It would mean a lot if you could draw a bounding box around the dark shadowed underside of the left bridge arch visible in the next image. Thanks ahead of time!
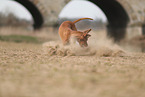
[14,0,44,29]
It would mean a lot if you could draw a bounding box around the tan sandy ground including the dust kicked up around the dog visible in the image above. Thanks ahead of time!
[0,27,145,97]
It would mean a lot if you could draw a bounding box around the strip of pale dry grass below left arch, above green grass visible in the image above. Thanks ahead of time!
[0,27,59,42]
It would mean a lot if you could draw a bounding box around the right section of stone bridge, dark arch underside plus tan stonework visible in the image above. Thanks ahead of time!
[58,0,145,41]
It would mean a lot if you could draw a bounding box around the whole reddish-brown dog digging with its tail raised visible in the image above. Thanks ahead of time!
[59,18,93,47]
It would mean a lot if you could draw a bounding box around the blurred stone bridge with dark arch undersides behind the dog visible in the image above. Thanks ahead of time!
[10,0,145,41]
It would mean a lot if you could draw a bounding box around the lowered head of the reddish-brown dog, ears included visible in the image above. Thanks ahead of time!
[72,29,91,47]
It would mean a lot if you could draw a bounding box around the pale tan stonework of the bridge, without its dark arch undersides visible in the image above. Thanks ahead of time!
[16,0,145,39]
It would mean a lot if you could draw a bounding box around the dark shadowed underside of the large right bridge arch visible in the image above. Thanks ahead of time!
[89,0,130,41]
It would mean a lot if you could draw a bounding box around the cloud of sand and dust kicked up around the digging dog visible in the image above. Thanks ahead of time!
[43,31,127,57]
